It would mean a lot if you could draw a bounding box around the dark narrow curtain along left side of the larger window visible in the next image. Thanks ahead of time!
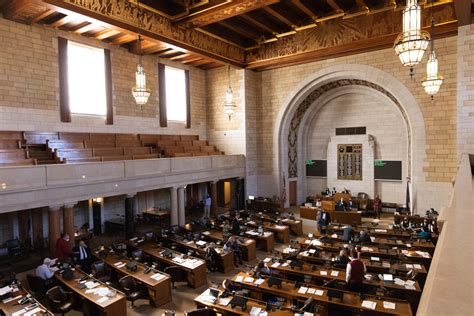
[58,37,71,123]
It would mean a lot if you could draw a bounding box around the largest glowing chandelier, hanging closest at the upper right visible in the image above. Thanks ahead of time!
[393,0,430,76]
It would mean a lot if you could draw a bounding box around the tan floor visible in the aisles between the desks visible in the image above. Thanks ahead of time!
[13,208,393,316]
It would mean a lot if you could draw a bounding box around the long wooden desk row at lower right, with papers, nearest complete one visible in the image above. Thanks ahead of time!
[232,272,412,315]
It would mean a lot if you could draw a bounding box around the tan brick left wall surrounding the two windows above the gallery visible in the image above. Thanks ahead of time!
[0,17,207,139]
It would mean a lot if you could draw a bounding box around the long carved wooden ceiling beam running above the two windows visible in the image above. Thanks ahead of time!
[39,0,246,67]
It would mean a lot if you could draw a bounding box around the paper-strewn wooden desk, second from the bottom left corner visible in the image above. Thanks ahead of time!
[54,269,127,316]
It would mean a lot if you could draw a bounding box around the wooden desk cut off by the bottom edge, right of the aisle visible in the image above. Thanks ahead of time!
[194,290,294,316]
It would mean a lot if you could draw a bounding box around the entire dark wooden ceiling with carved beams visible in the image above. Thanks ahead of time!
[0,0,472,69]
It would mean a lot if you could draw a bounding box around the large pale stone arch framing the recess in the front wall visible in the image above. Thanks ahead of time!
[274,64,426,207]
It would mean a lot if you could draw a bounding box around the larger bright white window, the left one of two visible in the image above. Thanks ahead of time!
[67,41,107,116]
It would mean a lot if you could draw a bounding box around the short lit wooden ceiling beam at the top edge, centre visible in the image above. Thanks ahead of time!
[173,0,280,28]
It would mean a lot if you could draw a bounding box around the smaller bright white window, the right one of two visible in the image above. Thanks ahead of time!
[165,66,187,123]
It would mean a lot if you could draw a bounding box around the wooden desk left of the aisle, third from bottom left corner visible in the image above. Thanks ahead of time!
[92,252,171,307]
